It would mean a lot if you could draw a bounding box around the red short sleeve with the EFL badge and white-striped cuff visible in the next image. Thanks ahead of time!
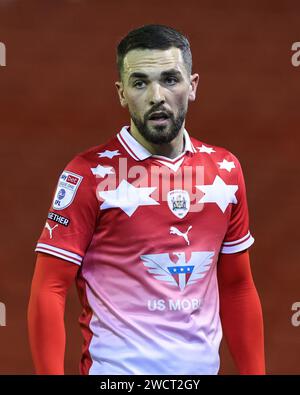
[35,156,98,265]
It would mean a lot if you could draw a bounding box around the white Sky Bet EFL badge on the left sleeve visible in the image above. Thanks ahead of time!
[52,171,82,210]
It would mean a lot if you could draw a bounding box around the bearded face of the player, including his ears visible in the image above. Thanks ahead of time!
[116,47,199,144]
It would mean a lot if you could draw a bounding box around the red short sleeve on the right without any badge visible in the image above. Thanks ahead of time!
[220,154,254,254]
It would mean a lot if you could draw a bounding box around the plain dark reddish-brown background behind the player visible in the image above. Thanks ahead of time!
[0,0,300,374]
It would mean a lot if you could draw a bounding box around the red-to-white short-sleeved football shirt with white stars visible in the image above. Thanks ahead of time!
[36,126,254,374]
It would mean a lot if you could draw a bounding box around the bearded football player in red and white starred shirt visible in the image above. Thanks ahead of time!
[28,25,265,375]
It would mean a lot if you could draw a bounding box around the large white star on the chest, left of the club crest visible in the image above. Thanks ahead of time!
[99,180,159,217]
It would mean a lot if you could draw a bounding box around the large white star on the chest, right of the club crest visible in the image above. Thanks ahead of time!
[196,176,238,213]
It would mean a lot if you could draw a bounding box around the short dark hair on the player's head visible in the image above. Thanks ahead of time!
[117,24,192,80]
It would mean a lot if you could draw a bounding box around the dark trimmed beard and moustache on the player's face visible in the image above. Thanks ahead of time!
[130,108,187,144]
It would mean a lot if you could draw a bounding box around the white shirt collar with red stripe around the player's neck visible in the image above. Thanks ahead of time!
[117,125,196,160]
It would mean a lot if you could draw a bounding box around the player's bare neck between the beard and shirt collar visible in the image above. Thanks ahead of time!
[130,120,184,159]
